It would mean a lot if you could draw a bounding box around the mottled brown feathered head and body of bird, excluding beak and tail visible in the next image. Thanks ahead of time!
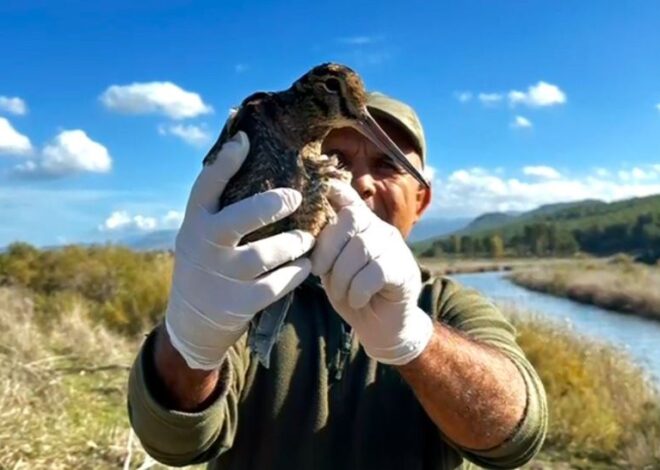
[204,64,366,243]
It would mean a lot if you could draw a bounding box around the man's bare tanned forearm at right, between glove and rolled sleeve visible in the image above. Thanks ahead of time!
[398,323,527,450]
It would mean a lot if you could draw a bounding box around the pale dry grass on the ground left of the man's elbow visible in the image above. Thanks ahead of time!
[0,288,159,469]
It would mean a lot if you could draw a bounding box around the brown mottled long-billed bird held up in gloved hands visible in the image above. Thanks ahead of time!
[203,63,429,368]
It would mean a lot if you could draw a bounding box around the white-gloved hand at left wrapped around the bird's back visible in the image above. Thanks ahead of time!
[165,132,314,370]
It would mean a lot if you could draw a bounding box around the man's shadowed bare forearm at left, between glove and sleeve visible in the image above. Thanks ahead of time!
[154,326,226,412]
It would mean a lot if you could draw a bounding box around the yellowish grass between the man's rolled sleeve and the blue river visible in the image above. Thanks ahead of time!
[507,310,660,469]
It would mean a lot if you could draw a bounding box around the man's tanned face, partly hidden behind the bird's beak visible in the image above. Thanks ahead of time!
[322,120,431,237]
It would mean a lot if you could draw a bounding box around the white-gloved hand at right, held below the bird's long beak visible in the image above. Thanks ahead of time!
[311,181,433,365]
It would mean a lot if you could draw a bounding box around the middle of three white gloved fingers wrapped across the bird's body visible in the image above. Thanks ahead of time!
[229,230,316,281]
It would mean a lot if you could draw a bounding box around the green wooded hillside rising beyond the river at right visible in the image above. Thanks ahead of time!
[414,195,660,261]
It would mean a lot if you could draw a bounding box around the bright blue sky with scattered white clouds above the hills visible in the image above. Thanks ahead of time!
[0,0,660,246]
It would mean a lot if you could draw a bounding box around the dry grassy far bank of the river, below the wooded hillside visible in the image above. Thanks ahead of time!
[509,255,660,320]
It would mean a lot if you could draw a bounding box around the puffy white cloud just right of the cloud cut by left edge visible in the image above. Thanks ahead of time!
[14,129,112,178]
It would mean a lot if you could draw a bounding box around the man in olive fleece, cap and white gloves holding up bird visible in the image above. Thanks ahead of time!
[128,94,547,469]
